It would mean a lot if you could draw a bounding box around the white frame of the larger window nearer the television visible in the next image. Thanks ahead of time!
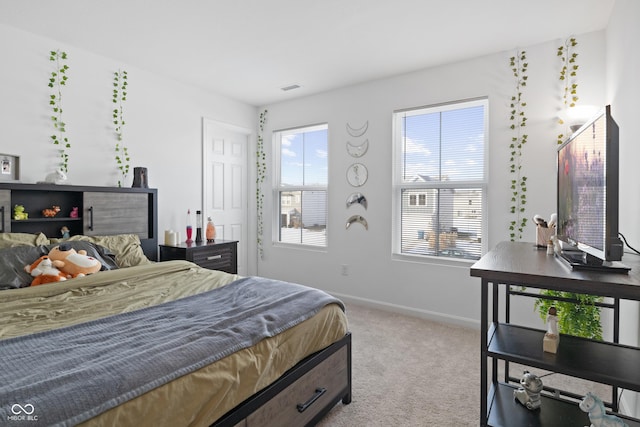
[391,97,490,264]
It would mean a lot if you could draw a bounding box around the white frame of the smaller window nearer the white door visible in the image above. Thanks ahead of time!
[271,122,331,252]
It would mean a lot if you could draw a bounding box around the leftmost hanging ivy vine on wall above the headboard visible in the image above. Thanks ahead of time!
[48,50,71,173]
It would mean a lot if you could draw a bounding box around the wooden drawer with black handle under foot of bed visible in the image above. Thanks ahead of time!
[246,346,349,427]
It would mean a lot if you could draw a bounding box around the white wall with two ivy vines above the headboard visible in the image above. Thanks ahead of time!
[0,25,257,249]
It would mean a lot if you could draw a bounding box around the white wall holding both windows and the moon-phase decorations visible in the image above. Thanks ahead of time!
[258,32,605,324]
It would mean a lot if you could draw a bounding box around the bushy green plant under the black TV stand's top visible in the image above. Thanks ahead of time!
[535,290,602,341]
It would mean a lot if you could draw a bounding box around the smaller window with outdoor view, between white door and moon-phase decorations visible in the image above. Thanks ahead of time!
[274,124,328,247]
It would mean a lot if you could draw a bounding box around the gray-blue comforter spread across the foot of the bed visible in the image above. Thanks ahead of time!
[0,277,344,426]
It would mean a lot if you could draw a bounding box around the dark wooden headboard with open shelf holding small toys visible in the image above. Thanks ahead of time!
[0,183,158,261]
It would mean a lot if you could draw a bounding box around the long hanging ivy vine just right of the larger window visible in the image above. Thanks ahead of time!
[509,51,529,241]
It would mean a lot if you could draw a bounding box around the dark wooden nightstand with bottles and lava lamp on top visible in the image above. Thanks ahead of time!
[160,240,238,274]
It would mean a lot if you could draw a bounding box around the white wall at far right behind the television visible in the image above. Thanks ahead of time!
[606,0,640,416]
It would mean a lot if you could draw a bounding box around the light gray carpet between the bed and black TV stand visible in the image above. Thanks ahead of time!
[319,305,480,427]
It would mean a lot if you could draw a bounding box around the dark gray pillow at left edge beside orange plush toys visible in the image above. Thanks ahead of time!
[0,245,47,289]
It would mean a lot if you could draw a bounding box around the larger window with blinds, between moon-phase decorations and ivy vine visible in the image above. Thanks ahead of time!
[393,99,488,259]
